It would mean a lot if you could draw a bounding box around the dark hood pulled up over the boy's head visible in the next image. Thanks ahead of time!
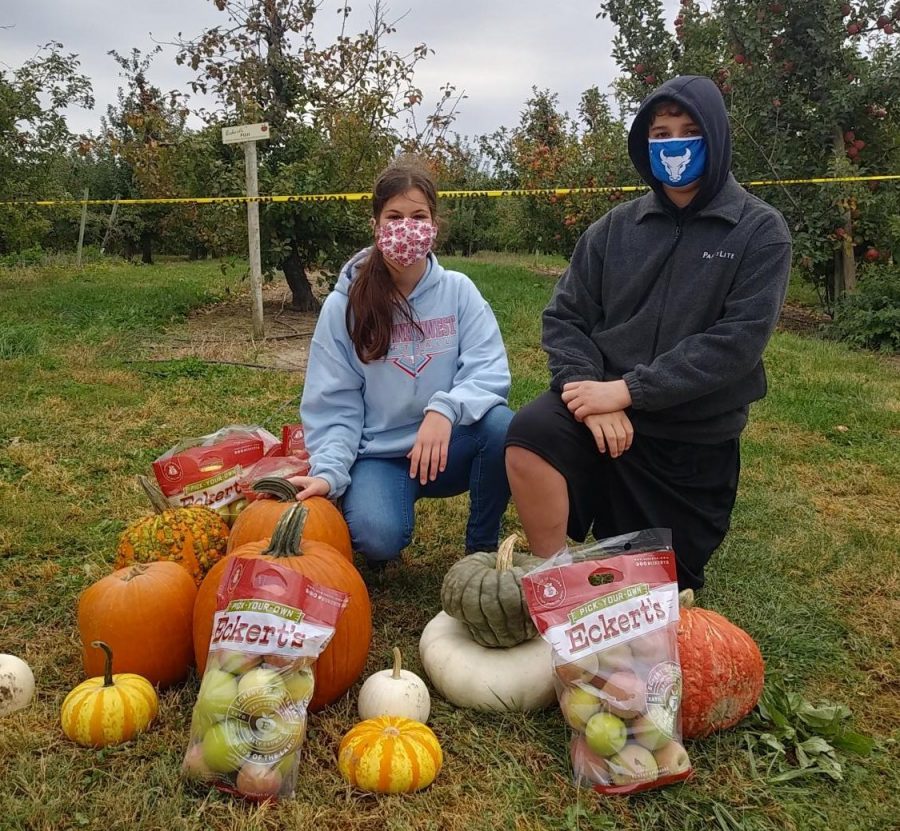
[628,75,731,212]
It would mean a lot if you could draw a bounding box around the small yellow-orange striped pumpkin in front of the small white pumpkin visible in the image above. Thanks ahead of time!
[338,716,444,793]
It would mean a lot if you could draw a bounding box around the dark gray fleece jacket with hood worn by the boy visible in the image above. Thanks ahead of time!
[542,76,791,444]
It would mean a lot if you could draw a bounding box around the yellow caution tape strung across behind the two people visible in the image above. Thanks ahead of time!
[0,174,900,208]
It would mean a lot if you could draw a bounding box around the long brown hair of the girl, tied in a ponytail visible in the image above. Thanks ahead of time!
[347,159,437,363]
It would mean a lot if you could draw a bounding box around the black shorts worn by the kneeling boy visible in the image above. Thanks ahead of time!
[506,391,741,588]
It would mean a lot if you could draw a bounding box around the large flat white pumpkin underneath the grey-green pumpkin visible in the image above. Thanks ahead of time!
[419,612,556,712]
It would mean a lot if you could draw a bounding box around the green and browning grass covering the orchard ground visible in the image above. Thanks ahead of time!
[0,255,900,831]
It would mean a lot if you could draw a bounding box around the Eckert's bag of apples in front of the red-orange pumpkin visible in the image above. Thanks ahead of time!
[522,529,691,794]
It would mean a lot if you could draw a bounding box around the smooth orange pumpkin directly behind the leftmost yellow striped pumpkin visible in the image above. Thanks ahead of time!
[78,561,197,687]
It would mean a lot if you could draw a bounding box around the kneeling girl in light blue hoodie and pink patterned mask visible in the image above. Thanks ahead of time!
[293,162,512,566]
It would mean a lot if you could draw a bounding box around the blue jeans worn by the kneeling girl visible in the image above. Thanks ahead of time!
[342,404,513,562]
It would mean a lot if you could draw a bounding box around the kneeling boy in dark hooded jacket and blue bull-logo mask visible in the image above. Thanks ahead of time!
[506,75,791,588]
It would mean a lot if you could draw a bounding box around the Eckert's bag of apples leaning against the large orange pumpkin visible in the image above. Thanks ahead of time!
[182,558,348,801]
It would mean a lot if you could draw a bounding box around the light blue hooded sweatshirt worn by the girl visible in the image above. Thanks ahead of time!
[300,249,510,498]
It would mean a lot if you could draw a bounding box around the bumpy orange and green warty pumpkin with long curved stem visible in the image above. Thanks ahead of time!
[116,476,228,585]
